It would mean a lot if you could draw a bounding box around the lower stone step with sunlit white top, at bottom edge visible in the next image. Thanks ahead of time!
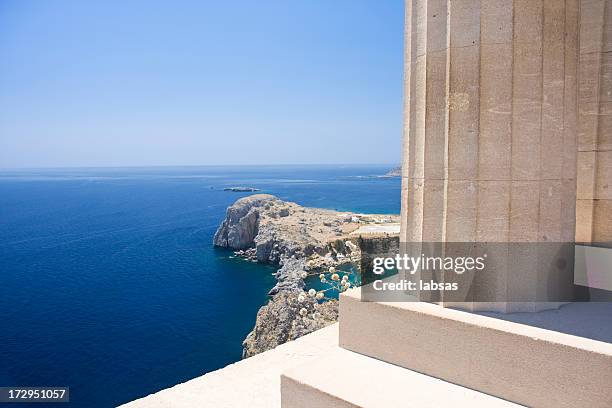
[281,347,519,408]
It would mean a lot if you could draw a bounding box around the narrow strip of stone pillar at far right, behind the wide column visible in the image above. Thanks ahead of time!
[576,0,612,247]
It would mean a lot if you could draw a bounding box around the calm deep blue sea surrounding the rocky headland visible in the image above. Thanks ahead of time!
[0,166,400,408]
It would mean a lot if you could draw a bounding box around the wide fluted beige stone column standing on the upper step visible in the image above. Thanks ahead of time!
[401,0,579,311]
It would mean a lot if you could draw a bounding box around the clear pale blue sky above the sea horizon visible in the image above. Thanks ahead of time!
[0,0,403,168]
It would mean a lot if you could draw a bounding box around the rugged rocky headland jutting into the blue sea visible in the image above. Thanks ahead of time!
[214,194,399,357]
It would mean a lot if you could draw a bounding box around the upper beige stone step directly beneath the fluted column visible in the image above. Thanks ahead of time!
[339,288,612,408]
